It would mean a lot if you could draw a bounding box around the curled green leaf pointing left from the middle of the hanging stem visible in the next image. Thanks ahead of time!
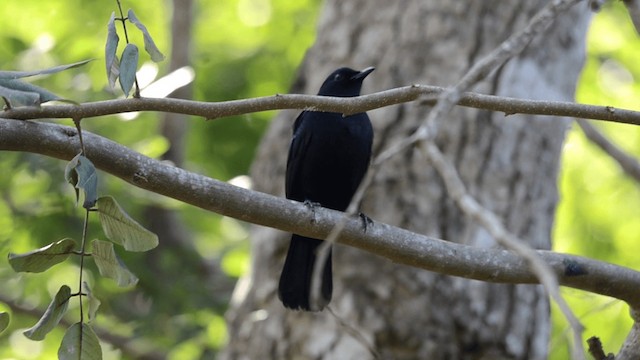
[9,238,76,273]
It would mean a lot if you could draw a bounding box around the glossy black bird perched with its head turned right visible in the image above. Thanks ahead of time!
[278,67,374,311]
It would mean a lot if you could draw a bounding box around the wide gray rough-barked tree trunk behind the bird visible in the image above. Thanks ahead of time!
[223,0,589,359]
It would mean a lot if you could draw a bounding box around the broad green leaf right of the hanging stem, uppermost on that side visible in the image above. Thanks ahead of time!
[97,196,158,251]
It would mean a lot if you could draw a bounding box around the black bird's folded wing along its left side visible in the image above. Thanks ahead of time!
[285,111,312,201]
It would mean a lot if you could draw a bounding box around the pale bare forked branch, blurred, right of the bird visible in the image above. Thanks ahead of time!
[382,0,585,359]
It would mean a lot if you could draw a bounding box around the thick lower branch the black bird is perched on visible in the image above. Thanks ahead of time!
[0,119,640,308]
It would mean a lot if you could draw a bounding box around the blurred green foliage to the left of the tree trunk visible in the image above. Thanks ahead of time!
[0,0,320,359]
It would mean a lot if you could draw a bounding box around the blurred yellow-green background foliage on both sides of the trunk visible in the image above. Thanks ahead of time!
[0,0,640,359]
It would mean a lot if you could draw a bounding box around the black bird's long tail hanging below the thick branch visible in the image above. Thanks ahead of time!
[278,234,333,311]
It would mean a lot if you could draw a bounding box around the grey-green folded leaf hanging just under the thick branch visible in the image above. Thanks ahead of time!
[64,154,98,209]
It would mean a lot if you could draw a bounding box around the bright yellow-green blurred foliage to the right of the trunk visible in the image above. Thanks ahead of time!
[551,1,640,359]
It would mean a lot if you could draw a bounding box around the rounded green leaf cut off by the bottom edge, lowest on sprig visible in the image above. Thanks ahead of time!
[58,322,102,360]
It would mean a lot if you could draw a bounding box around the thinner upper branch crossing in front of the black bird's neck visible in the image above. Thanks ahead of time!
[0,85,640,125]
